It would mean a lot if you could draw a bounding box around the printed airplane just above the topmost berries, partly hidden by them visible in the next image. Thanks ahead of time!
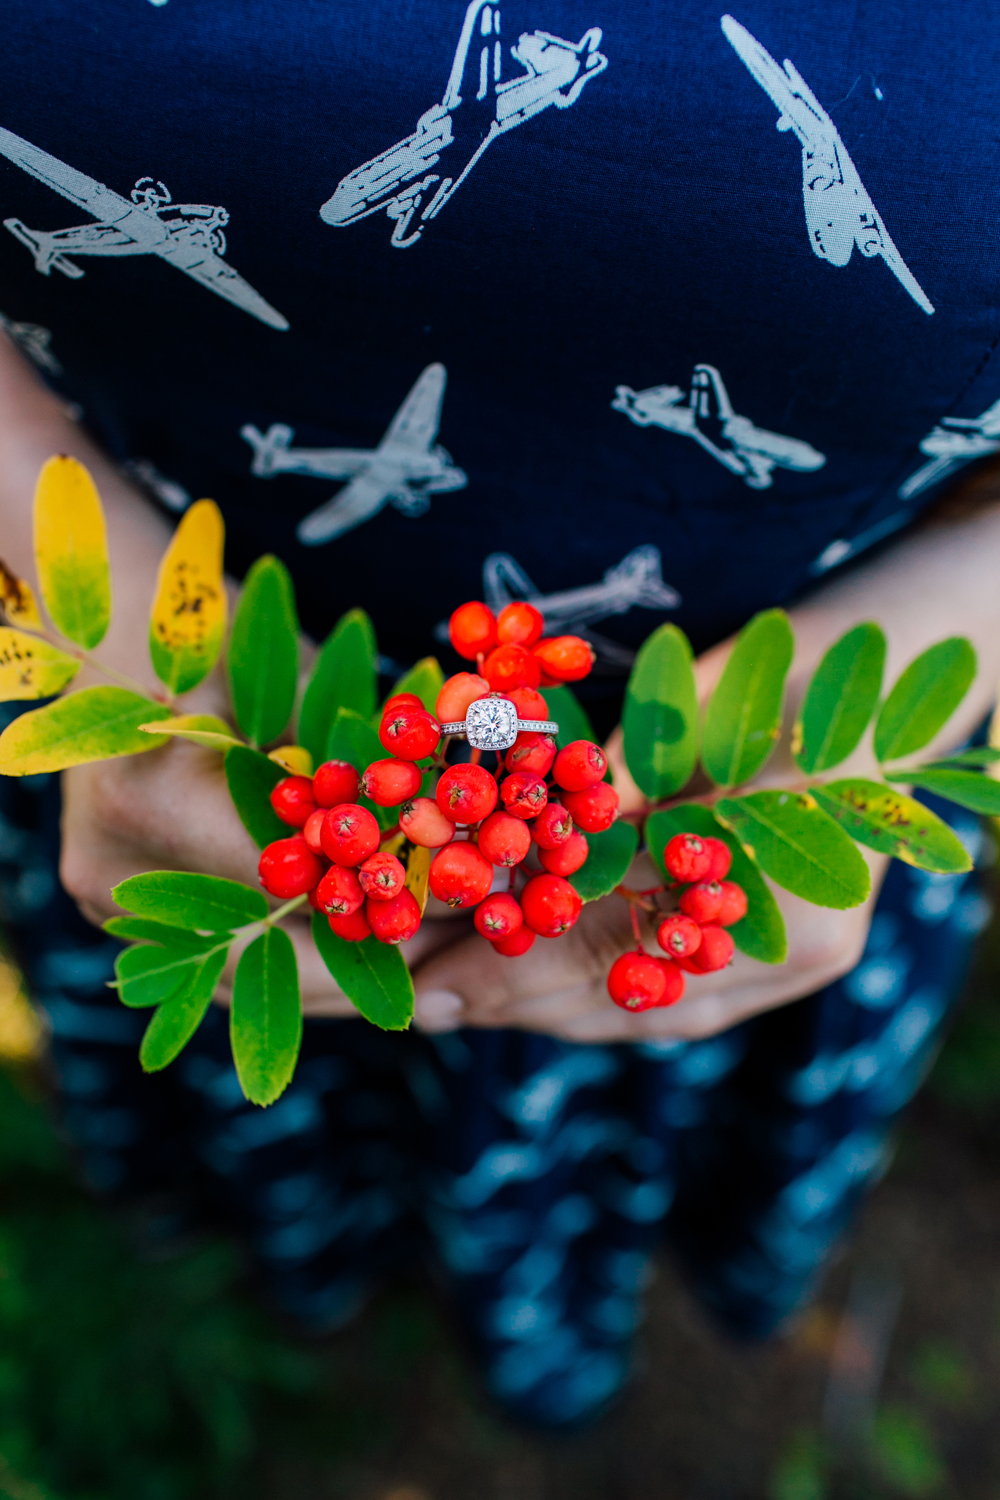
[435,546,681,672]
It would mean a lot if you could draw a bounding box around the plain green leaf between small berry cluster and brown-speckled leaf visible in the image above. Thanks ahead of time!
[715,792,871,911]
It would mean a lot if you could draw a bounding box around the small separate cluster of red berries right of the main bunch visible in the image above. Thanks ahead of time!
[607,834,747,1011]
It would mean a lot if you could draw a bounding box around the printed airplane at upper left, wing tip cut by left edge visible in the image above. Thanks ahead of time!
[0,128,288,329]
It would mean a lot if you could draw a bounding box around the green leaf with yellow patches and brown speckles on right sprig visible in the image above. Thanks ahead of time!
[813,777,971,875]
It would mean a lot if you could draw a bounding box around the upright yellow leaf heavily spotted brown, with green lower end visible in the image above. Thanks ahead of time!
[150,500,226,693]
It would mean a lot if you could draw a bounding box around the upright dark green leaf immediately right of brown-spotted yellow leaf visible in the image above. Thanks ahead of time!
[228,557,298,746]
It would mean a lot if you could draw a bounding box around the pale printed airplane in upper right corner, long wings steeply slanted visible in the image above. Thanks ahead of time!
[721,15,934,314]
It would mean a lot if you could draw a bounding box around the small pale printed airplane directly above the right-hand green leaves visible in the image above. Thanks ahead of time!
[612,365,826,489]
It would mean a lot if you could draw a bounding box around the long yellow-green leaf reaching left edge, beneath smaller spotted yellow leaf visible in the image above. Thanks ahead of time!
[0,687,169,776]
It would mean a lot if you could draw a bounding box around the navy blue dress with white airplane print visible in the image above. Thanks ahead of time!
[0,0,1000,1424]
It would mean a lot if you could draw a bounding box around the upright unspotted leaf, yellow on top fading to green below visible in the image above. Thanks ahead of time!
[34,455,111,651]
